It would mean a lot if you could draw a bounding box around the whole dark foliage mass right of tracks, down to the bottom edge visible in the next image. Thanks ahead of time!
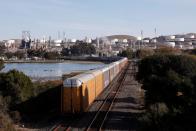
[137,55,196,131]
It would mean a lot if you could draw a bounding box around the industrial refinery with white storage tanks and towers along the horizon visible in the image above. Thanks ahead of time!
[0,31,196,56]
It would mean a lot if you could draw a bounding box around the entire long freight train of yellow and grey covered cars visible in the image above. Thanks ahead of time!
[61,58,128,114]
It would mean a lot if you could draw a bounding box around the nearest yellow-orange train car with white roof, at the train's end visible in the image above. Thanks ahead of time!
[62,74,96,113]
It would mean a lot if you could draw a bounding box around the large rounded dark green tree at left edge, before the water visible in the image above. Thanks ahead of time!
[0,70,33,105]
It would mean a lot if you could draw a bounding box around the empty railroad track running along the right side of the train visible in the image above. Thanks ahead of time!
[85,64,129,131]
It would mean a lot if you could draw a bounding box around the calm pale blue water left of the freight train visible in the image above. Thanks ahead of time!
[2,63,104,80]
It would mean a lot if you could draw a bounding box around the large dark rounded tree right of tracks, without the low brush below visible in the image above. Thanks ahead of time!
[137,55,196,111]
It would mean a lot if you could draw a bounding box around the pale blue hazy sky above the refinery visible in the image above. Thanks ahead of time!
[0,0,196,40]
